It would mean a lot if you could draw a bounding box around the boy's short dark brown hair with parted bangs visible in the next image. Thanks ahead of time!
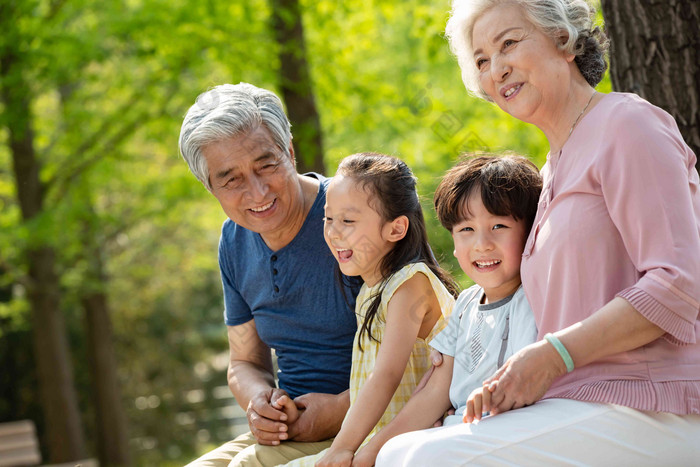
[434,155,542,232]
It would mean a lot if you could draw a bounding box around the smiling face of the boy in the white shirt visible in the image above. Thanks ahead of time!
[452,190,527,303]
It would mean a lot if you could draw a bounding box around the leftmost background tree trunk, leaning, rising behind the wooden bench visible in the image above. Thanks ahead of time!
[0,48,86,462]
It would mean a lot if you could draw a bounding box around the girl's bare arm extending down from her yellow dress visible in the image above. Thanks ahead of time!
[316,274,441,466]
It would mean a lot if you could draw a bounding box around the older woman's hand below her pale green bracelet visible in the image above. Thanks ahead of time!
[484,340,566,415]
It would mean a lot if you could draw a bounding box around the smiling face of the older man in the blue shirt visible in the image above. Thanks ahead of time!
[202,126,303,238]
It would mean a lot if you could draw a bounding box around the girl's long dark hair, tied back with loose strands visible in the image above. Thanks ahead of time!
[338,152,459,350]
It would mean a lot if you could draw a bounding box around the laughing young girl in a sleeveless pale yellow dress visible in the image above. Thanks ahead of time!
[280,153,458,466]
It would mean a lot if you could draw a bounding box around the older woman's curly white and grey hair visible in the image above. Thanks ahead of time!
[445,0,606,100]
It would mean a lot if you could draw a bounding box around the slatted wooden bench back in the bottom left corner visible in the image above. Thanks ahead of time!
[0,420,41,467]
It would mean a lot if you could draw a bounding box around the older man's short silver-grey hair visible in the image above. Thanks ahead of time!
[179,83,292,191]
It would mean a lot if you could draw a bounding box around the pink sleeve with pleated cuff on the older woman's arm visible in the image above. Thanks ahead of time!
[599,99,700,345]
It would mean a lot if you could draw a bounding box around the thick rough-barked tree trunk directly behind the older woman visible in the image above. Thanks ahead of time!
[602,0,700,172]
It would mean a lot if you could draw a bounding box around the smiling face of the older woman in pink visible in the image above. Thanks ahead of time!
[472,3,574,126]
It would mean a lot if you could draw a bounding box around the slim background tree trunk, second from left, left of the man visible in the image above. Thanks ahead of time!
[81,214,131,466]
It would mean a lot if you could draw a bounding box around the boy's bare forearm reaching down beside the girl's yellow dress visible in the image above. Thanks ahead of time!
[352,355,454,466]
